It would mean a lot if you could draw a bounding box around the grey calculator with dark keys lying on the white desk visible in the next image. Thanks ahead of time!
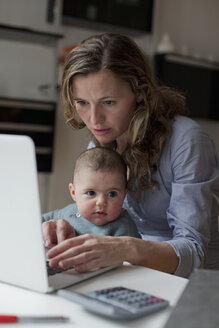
[57,287,169,320]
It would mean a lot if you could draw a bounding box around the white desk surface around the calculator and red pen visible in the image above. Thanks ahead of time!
[0,265,188,328]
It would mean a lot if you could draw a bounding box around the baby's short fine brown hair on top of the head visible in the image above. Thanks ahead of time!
[73,147,127,186]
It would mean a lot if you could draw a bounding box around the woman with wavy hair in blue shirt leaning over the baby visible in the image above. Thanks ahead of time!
[43,33,219,277]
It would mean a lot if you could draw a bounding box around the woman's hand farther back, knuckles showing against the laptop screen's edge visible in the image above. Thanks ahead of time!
[42,219,76,247]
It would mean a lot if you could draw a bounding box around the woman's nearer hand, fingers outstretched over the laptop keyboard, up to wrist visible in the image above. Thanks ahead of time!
[47,234,131,272]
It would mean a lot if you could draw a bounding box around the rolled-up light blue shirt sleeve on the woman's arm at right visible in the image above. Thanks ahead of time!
[167,125,219,277]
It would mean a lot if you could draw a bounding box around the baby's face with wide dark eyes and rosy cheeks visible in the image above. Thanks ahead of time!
[70,168,126,225]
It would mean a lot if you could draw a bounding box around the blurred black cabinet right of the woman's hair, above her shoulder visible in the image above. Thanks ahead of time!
[154,54,219,120]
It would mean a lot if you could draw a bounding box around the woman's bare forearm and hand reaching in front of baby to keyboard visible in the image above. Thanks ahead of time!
[48,234,178,273]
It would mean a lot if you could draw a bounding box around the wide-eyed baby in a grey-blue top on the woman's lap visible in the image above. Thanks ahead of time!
[42,147,140,246]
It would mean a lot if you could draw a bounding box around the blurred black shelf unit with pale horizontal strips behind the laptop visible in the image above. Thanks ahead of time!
[0,97,56,172]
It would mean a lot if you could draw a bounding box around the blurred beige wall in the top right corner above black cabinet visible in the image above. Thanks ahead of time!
[156,0,219,62]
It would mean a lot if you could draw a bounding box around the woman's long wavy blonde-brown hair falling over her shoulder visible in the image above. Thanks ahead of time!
[62,33,186,191]
